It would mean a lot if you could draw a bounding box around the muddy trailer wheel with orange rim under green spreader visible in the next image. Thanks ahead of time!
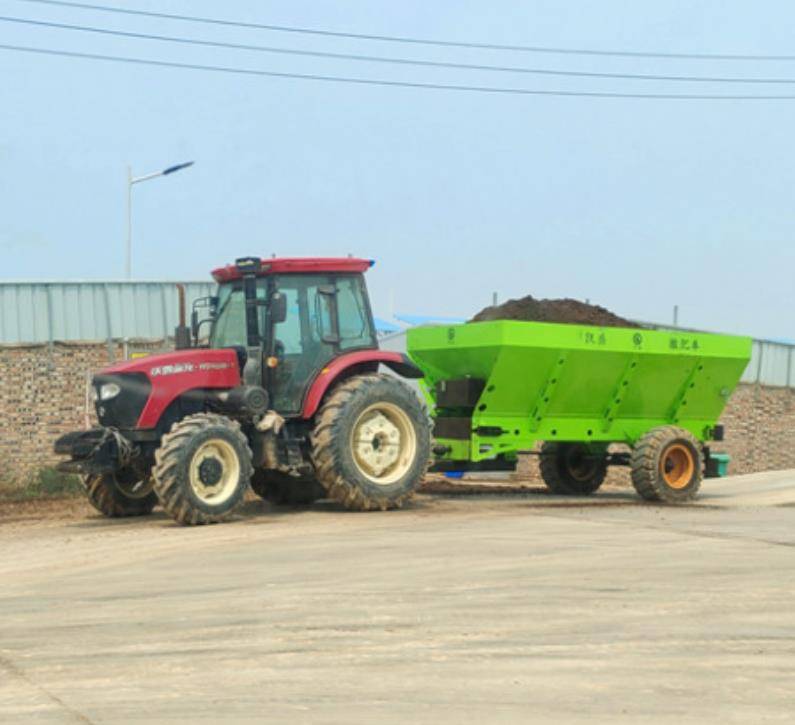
[631,425,704,503]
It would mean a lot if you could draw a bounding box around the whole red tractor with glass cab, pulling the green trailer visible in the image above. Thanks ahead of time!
[55,257,430,524]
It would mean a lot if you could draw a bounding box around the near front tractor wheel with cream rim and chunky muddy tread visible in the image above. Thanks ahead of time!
[153,413,253,524]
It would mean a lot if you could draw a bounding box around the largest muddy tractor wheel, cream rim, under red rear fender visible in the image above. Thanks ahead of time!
[311,374,431,511]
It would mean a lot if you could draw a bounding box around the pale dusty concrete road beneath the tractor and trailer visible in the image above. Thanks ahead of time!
[0,472,795,725]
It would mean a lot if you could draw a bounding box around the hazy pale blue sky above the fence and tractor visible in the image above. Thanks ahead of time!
[0,0,795,339]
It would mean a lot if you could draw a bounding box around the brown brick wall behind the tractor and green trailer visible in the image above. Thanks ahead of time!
[0,340,795,484]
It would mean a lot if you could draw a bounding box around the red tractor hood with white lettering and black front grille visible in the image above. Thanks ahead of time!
[94,348,240,429]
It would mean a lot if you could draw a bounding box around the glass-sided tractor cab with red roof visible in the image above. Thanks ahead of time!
[193,258,378,416]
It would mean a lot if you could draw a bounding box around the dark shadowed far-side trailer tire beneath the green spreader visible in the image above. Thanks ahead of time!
[539,442,607,496]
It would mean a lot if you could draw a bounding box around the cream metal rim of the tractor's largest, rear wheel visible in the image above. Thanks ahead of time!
[350,402,417,486]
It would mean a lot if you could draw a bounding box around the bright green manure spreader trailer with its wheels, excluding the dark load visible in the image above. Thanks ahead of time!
[408,321,751,503]
